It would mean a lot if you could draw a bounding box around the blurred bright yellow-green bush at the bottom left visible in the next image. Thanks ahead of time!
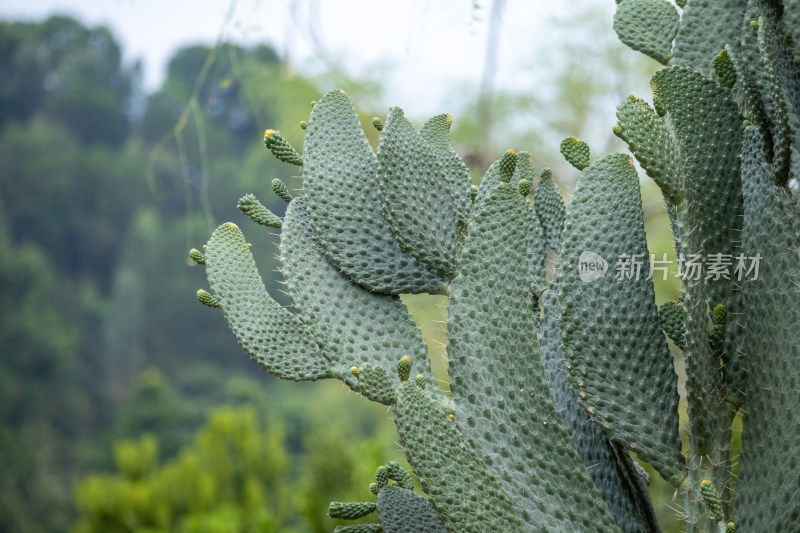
[74,406,384,533]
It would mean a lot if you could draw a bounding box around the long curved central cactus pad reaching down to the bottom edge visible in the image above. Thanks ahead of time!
[448,184,613,531]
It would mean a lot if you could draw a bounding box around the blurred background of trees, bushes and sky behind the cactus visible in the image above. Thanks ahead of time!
[0,0,680,533]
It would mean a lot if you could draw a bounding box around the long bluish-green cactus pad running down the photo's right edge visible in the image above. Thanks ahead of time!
[735,126,800,531]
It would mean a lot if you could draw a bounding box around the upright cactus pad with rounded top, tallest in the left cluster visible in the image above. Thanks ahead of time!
[303,90,447,294]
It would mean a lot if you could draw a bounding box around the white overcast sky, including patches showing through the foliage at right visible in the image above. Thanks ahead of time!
[0,0,664,164]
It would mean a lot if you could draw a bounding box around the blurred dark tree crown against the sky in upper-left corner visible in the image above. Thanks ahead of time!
[0,17,136,146]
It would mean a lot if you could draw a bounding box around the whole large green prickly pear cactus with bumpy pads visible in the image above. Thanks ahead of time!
[191,0,800,533]
